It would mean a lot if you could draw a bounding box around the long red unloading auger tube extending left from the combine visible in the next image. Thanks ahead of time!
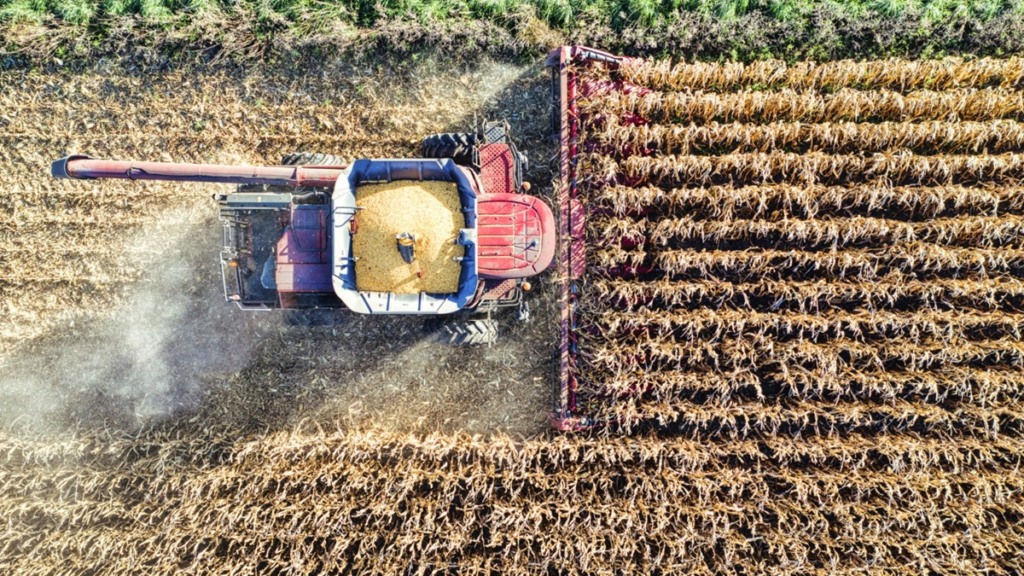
[50,155,346,188]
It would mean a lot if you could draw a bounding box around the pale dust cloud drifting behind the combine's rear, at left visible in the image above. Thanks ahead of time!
[0,205,251,431]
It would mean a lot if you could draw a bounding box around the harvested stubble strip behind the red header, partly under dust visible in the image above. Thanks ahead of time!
[0,61,554,435]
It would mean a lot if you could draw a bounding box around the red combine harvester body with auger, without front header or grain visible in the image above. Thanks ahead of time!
[52,122,555,344]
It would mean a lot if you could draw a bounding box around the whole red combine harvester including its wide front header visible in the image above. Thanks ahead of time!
[52,46,632,430]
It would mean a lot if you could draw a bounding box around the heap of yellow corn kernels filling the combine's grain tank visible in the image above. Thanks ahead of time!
[352,180,465,294]
